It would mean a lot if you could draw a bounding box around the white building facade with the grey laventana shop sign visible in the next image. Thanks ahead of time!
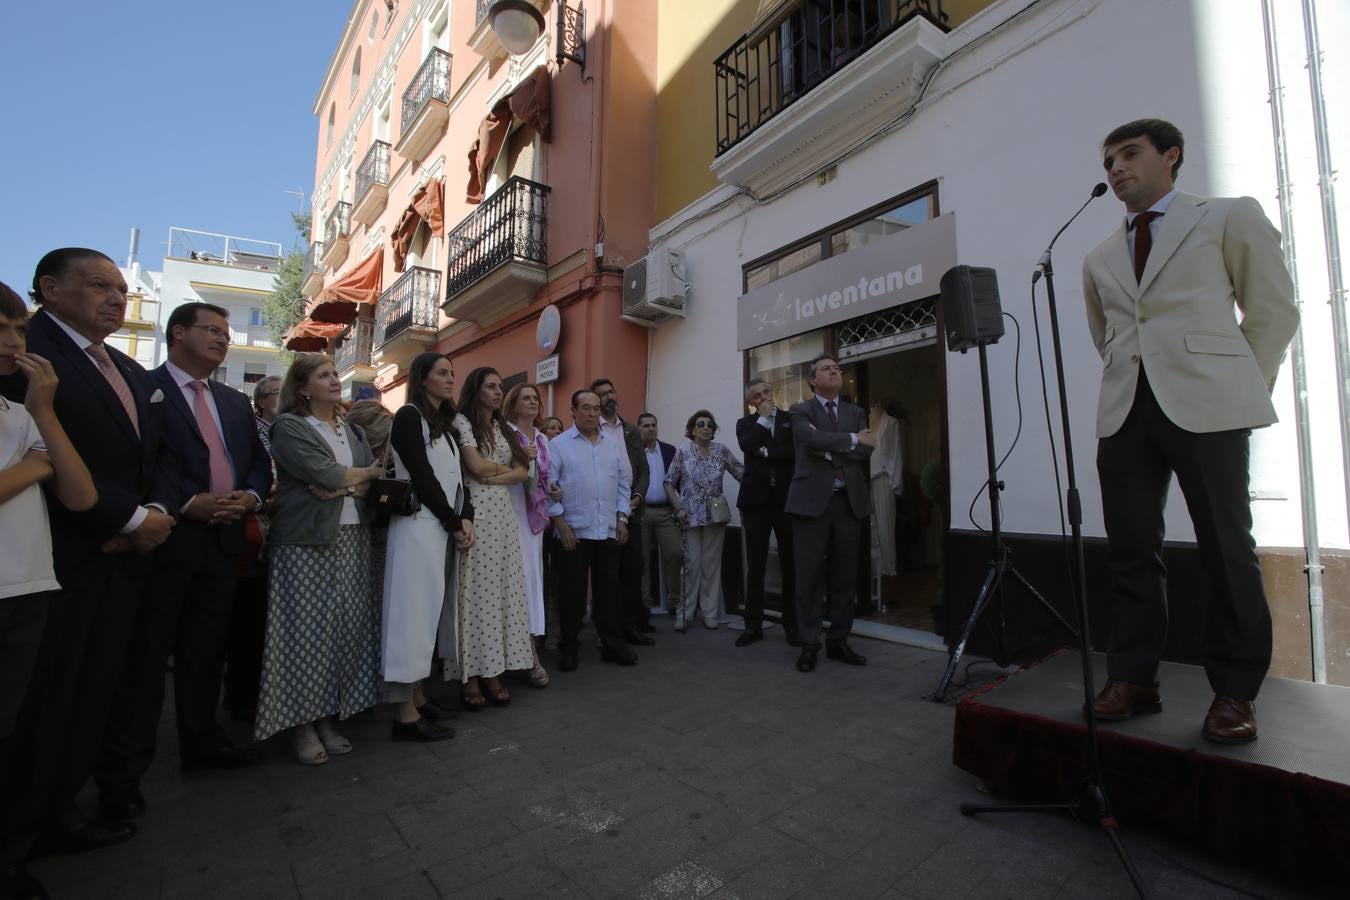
[648,0,1350,684]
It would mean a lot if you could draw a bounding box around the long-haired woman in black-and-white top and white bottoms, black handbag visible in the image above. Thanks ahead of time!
[381,354,474,741]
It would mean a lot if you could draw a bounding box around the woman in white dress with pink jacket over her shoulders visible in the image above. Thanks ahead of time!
[502,385,549,688]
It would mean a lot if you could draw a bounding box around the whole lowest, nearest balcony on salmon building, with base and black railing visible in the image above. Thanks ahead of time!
[443,175,551,325]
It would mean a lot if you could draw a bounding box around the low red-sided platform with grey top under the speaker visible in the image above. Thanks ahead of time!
[953,650,1350,885]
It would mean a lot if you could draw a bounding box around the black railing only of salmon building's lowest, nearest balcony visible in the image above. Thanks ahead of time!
[446,175,551,300]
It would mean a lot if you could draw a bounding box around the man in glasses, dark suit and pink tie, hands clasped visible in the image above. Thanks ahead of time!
[95,302,271,819]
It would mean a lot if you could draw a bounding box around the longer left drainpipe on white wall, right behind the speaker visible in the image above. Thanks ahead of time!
[1261,0,1327,684]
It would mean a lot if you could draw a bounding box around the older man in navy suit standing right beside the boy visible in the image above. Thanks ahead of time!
[20,247,182,853]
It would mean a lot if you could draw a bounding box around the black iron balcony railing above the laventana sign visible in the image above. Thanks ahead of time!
[713,0,948,155]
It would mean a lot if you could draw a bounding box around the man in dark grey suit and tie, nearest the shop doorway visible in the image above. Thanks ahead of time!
[786,355,876,672]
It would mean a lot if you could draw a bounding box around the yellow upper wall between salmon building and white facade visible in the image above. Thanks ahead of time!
[656,0,994,223]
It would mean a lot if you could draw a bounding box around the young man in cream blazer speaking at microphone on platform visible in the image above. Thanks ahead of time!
[1083,119,1299,743]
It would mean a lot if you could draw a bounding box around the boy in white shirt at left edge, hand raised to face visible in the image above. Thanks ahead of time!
[0,283,99,897]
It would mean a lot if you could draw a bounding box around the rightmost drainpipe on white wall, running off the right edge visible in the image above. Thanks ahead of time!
[1303,0,1350,555]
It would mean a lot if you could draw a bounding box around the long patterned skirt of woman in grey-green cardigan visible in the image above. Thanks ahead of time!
[254,525,379,741]
